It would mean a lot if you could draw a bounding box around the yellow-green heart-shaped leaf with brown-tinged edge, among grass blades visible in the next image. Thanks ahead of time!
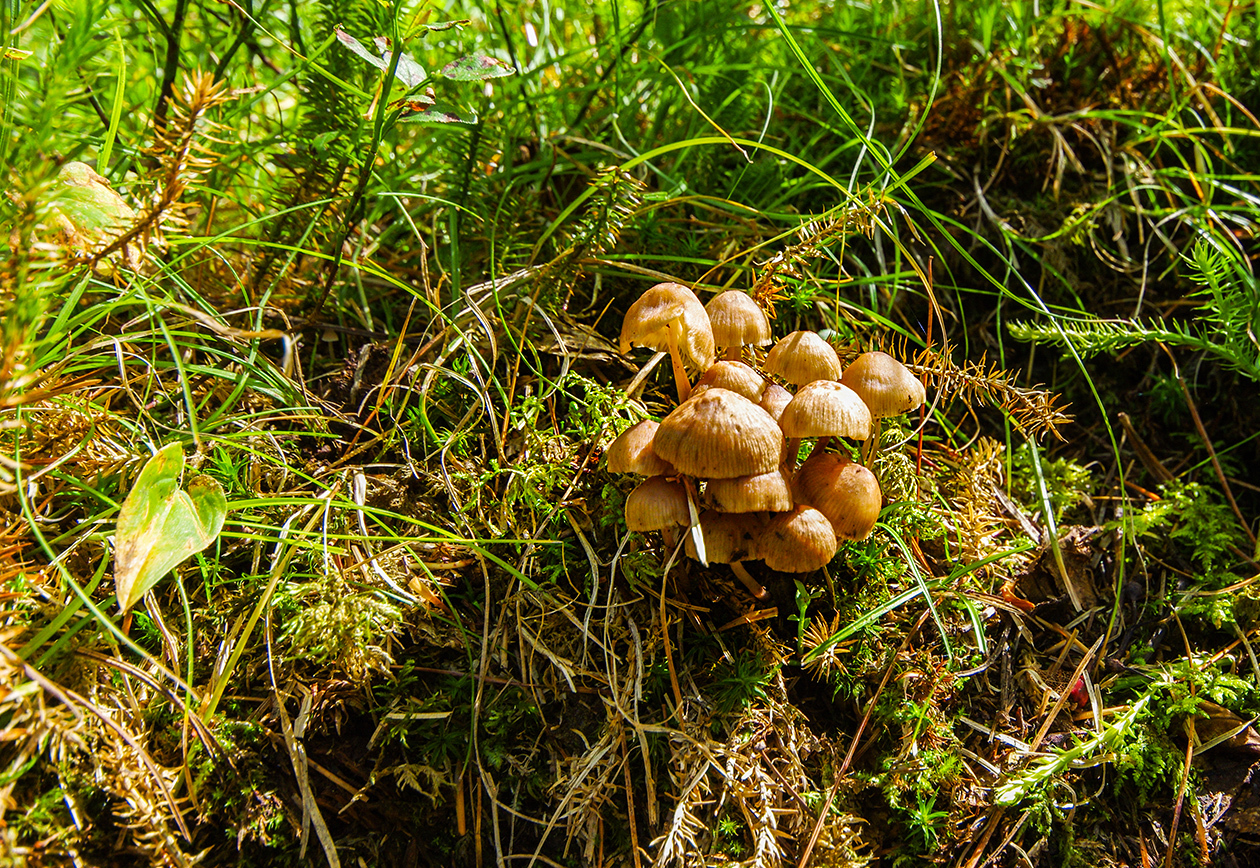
[113,443,228,612]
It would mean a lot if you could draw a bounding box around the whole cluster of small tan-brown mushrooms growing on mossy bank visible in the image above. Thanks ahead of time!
[607,283,925,598]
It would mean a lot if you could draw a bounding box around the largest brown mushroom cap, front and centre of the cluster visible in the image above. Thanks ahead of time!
[653,388,784,479]
